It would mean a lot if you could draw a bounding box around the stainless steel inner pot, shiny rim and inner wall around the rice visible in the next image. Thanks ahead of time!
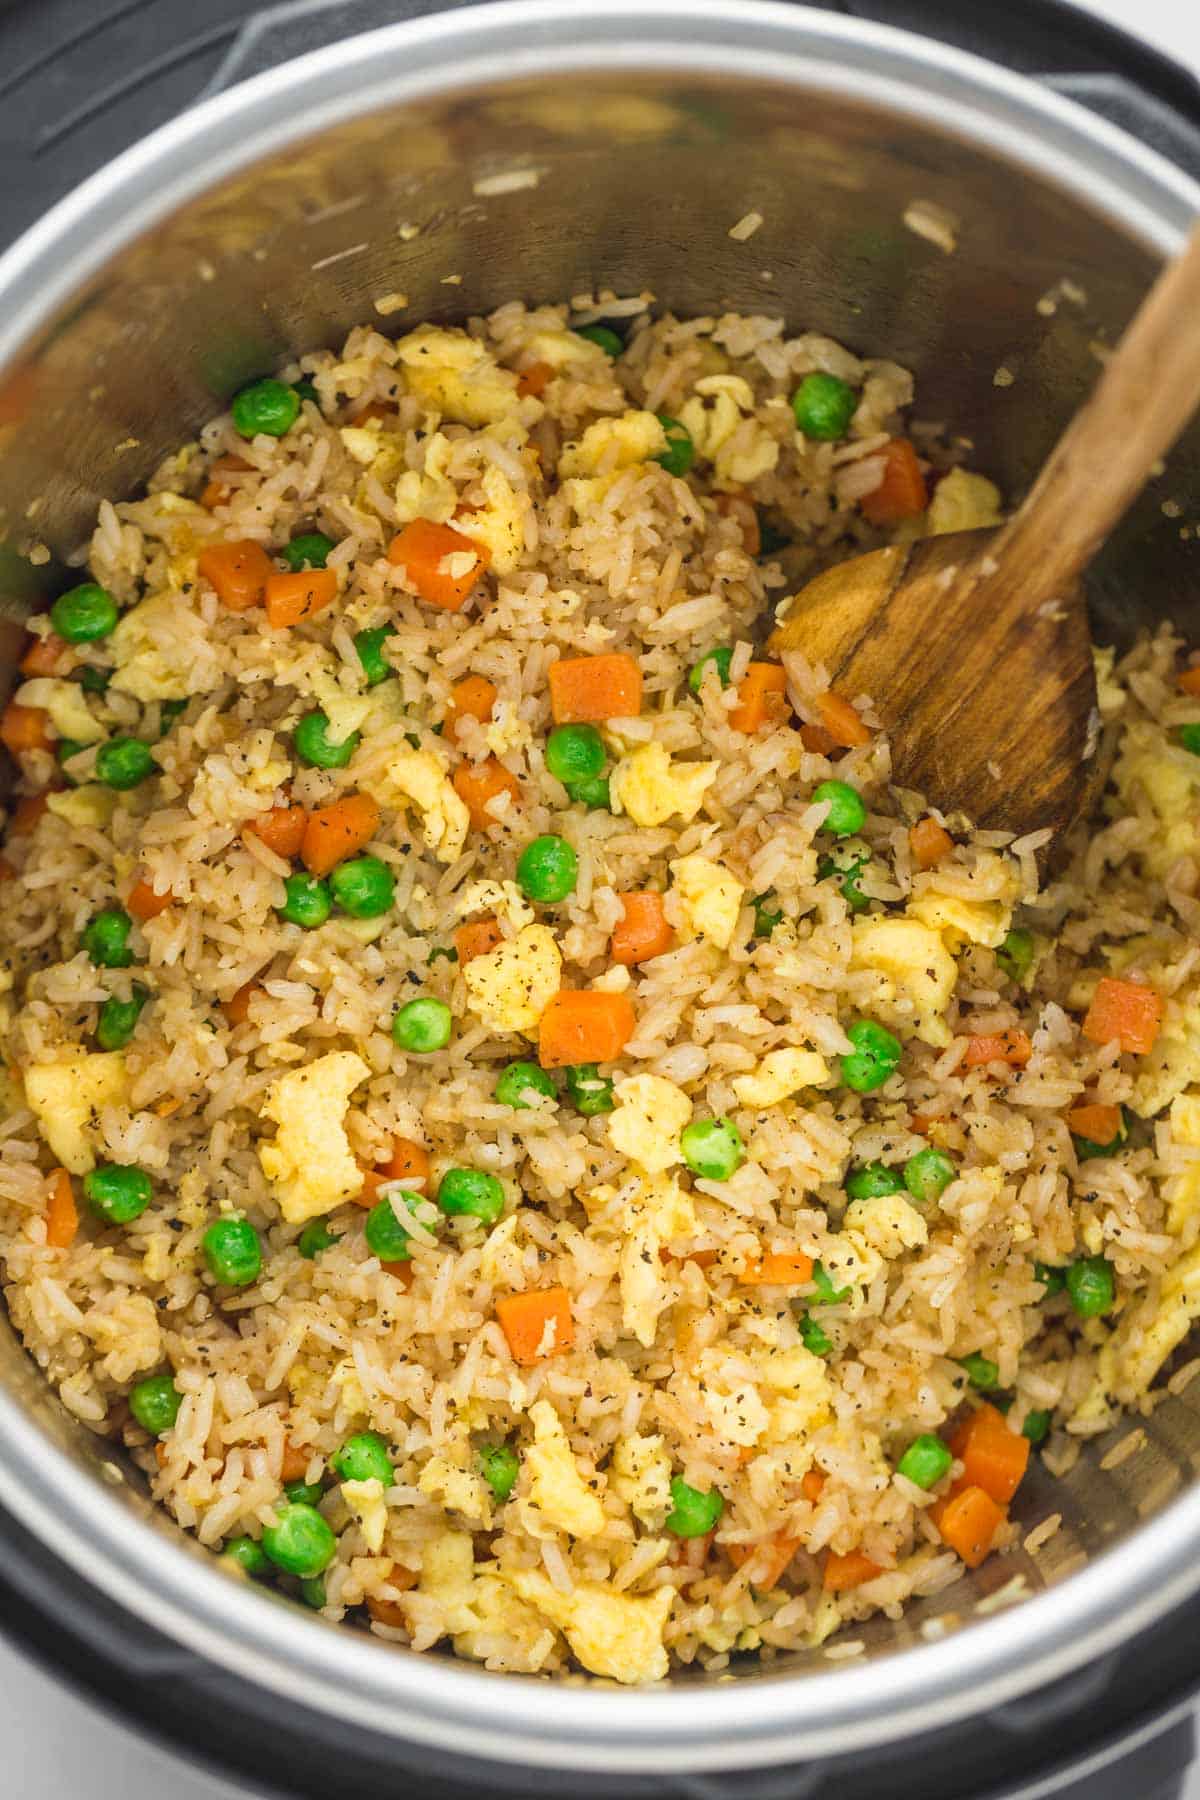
[0,0,1200,1771]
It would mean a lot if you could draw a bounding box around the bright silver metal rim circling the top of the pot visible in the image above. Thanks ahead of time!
[0,0,1200,1773]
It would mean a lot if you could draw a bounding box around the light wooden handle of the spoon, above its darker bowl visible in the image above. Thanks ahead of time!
[993,227,1200,608]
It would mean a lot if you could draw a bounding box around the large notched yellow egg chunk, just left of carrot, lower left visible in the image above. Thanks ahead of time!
[259,1049,371,1226]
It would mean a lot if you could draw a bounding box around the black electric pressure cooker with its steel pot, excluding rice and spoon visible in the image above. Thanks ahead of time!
[0,0,1200,1800]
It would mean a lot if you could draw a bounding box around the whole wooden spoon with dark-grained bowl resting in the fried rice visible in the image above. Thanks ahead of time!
[768,229,1200,835]
